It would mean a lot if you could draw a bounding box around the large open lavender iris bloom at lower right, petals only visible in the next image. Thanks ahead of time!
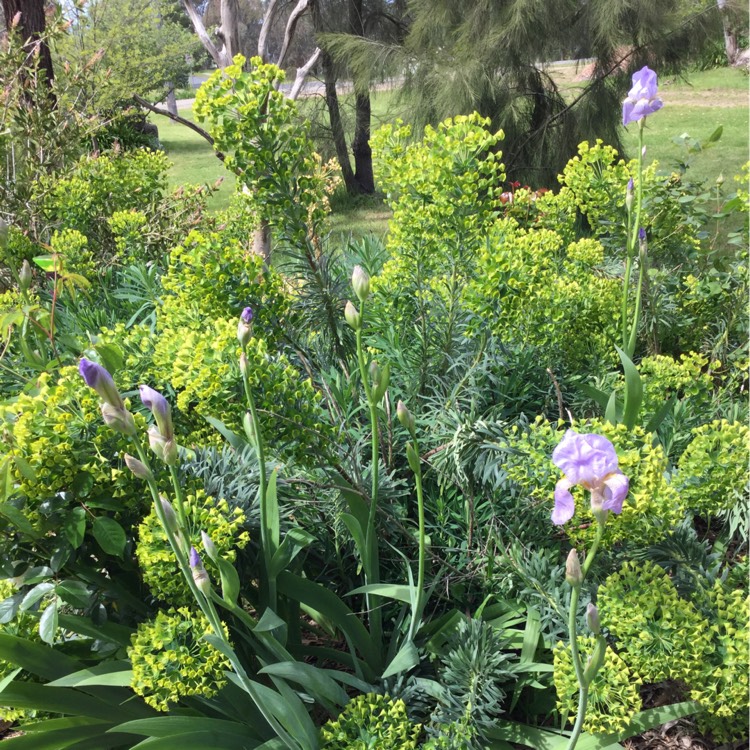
[552,430,629,526]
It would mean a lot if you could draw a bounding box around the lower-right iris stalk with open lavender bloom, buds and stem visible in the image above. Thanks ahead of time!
[552,430,629,750]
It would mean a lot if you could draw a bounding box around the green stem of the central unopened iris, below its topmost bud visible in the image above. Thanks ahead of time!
[356,301,383,643]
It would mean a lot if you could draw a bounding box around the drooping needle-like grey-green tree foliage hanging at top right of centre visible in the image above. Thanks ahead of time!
[325,0,716,187]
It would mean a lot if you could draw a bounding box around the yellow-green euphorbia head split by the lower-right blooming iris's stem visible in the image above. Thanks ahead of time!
[553,636,642,734]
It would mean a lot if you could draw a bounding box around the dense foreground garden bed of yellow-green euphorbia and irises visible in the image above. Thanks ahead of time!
[0,38,750,750]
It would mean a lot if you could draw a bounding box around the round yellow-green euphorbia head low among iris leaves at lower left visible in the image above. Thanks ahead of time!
[128,607,230,711]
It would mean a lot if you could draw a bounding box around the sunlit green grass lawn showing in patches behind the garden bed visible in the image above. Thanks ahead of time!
[151,66,748,232]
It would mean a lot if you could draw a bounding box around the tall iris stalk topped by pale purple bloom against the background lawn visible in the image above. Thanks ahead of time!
[621,67,663,359]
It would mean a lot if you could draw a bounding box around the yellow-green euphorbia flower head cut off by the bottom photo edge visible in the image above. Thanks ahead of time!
[320,693,422,750]
